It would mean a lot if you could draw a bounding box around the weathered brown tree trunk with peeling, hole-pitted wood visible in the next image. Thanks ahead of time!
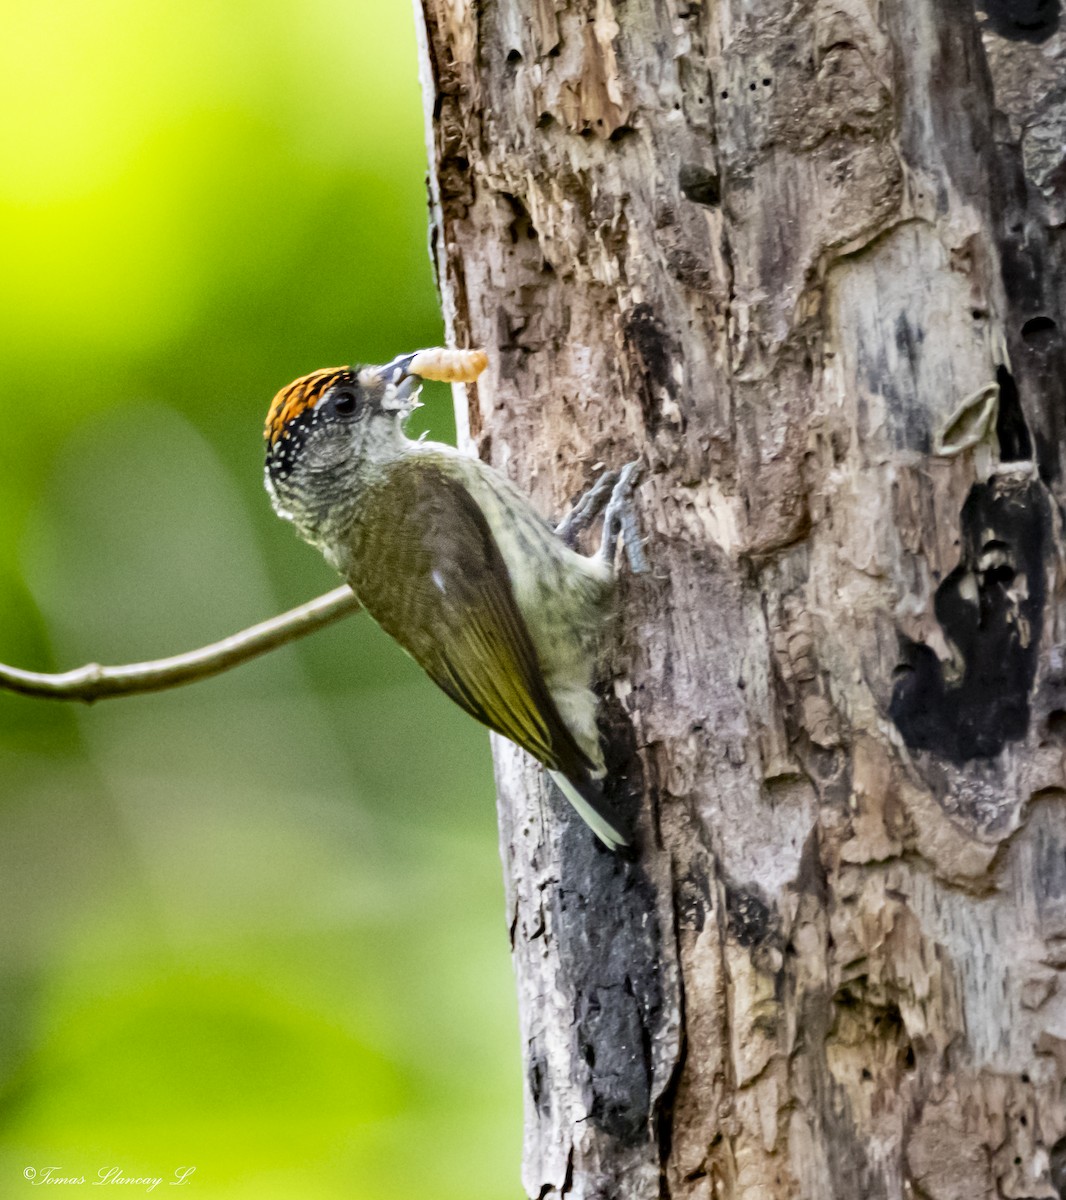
[412,0,1066,1200]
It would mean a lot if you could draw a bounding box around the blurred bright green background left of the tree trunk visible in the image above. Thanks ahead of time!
[0,0,521,1200]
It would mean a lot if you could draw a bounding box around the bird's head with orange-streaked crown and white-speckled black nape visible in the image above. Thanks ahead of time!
[264,355,423,542]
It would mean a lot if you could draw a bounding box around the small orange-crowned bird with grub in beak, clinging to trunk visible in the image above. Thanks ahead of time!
[264,349,647,851]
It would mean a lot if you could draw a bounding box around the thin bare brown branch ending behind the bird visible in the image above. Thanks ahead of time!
[0,584,360,704]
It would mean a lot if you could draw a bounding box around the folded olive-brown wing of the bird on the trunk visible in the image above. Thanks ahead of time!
[348,458,592,779]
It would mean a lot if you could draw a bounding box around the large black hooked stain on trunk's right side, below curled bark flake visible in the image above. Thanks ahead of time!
[890,478,1052,763]
